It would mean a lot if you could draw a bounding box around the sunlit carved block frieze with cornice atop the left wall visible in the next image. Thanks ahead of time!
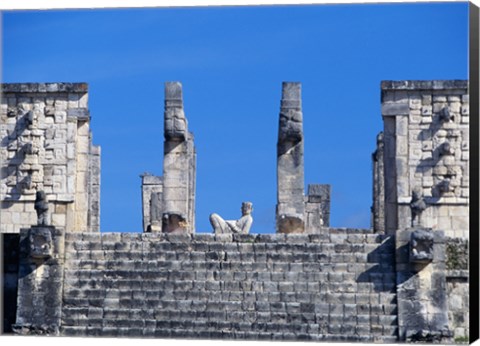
[0,83,89,202]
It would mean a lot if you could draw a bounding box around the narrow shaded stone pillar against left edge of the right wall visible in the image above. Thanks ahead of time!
[372,132,385,234]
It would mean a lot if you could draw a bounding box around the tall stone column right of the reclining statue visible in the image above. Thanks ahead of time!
[276,82,305,233]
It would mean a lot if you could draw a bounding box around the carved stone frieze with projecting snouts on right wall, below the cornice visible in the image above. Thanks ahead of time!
[406,93,468,204]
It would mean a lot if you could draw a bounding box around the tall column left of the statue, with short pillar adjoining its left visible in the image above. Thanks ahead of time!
[141,82,196,233]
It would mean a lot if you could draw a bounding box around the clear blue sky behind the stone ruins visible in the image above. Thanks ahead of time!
[2,2,468,233]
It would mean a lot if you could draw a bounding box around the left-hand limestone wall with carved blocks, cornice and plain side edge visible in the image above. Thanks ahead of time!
[0,83,100,233]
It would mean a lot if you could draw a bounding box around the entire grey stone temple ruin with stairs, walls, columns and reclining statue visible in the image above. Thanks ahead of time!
[0,80,470,343]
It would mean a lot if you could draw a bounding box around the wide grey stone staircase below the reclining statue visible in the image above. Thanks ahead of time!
[60,229,397,342]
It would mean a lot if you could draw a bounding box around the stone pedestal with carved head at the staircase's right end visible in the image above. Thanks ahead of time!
[395,228,451,342]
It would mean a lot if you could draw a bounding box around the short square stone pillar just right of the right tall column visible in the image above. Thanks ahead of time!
[305,184,330,233]
